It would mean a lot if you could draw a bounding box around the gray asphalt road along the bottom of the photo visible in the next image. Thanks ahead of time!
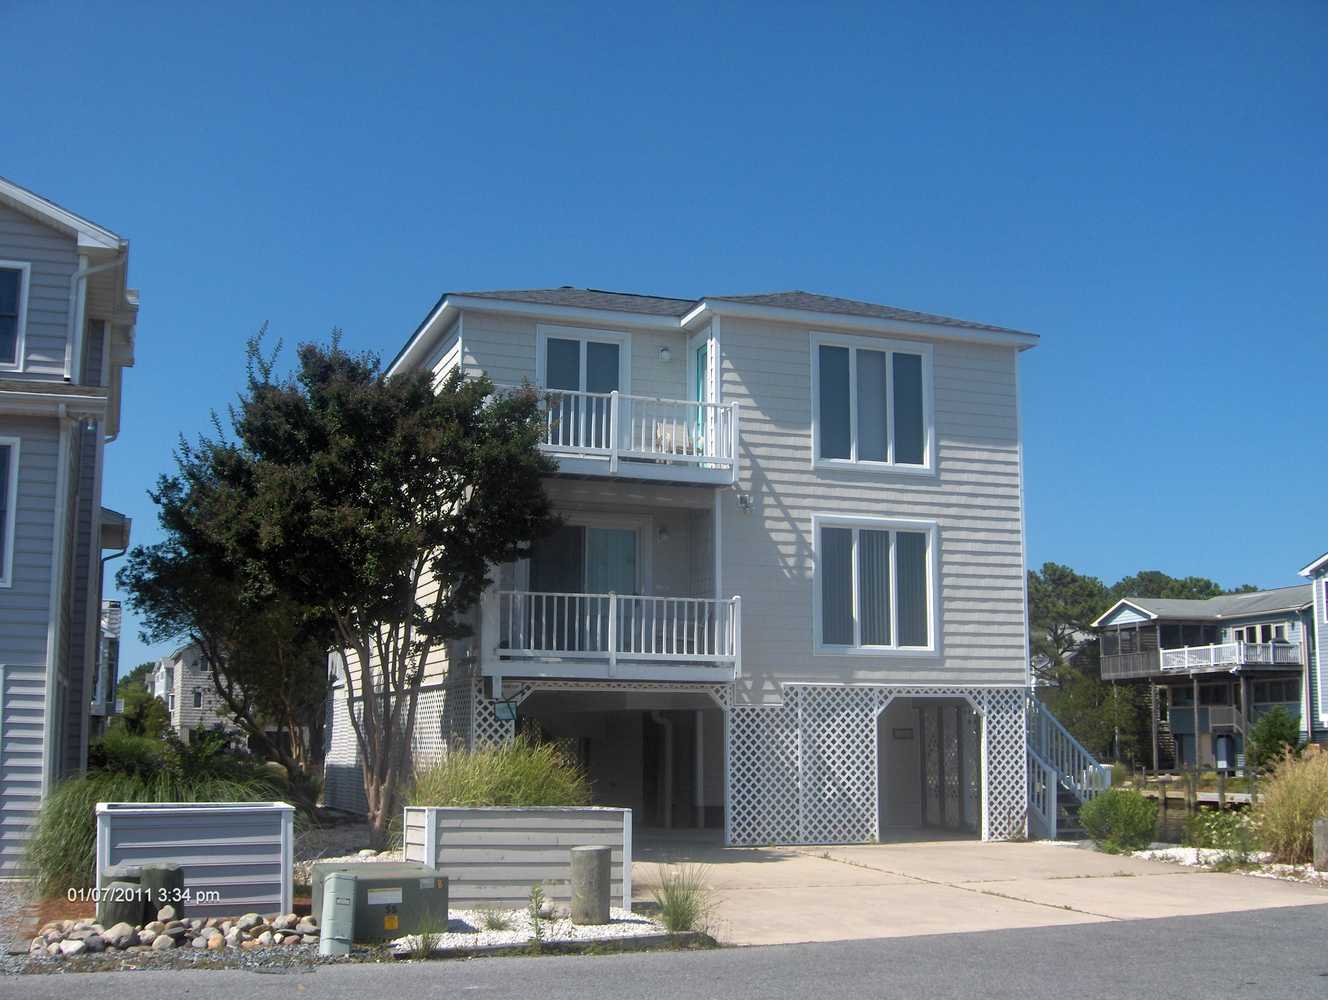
[10,904,1328,1000]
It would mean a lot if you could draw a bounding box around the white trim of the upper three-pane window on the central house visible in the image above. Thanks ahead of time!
[810,331,936,477]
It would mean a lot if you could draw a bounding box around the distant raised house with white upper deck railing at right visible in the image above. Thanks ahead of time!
[1093,584,1328,770]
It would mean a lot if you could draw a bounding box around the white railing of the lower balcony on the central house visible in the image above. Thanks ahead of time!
[481,591,742,676]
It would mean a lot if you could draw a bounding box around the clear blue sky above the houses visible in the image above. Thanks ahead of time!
[0,0,1328,669]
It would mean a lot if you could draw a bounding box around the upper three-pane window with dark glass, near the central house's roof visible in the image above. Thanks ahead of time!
[811,333,935,473]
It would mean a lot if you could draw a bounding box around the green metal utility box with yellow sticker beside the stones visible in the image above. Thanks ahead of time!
[309,861,448,944]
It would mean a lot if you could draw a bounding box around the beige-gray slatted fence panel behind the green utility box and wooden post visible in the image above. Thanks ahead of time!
[402,806,632,908]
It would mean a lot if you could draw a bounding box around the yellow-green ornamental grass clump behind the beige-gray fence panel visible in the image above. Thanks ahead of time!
[405,736,590,806]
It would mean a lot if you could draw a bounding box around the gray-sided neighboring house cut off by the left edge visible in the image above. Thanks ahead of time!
[0,179,138,871]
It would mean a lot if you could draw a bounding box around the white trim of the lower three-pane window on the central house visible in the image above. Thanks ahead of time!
[811,514,940,659]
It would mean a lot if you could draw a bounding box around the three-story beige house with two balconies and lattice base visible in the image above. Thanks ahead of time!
[327,287,1102,845]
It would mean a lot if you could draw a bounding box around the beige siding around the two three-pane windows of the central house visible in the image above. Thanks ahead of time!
[720,319,1027,700]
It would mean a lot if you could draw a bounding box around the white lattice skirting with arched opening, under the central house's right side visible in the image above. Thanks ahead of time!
[725,685,1028,845]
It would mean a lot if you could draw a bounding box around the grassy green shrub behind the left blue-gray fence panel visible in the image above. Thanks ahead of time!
[28,752,282,896]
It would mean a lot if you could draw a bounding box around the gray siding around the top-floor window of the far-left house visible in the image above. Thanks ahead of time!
[0,206,78,378]
